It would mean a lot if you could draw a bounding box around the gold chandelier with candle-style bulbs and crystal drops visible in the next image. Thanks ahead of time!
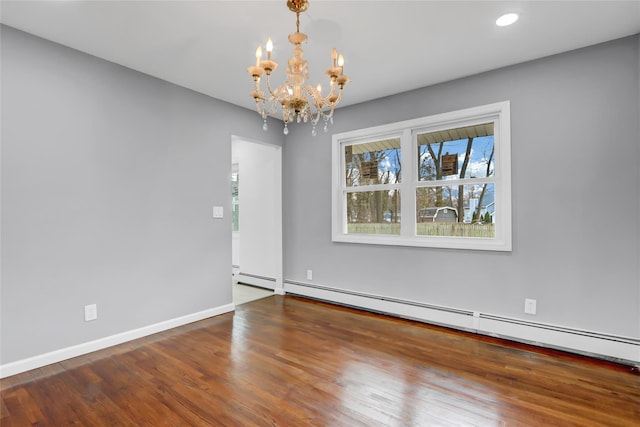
[247,0,350,136]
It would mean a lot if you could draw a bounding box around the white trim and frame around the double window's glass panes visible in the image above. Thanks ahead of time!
[331,101,512,251]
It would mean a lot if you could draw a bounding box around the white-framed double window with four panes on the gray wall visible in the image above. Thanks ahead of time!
[332,101,511,251]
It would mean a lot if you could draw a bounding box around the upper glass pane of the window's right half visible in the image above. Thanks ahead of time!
[417,123,494,181]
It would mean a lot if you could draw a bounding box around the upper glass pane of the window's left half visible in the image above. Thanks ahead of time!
[344,138,401,187]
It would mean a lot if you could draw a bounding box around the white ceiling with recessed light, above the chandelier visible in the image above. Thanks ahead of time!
[0,0,640,113]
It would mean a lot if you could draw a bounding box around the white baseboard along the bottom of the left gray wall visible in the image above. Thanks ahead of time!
[0,304,235,378]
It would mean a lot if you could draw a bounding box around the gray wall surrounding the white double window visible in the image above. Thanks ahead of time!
[283,36,640,337]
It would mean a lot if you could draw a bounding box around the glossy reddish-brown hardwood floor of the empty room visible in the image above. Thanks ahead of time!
[0,296,640,427]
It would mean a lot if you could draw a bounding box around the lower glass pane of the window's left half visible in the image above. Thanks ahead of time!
[346,190,400,234]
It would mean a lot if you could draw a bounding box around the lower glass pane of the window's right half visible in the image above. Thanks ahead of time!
[416,183,495,237]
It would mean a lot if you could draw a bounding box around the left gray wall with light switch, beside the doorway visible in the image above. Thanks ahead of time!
[0,26,283,364]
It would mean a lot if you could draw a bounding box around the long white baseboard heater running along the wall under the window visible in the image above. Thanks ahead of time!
[284,280,640,366]
